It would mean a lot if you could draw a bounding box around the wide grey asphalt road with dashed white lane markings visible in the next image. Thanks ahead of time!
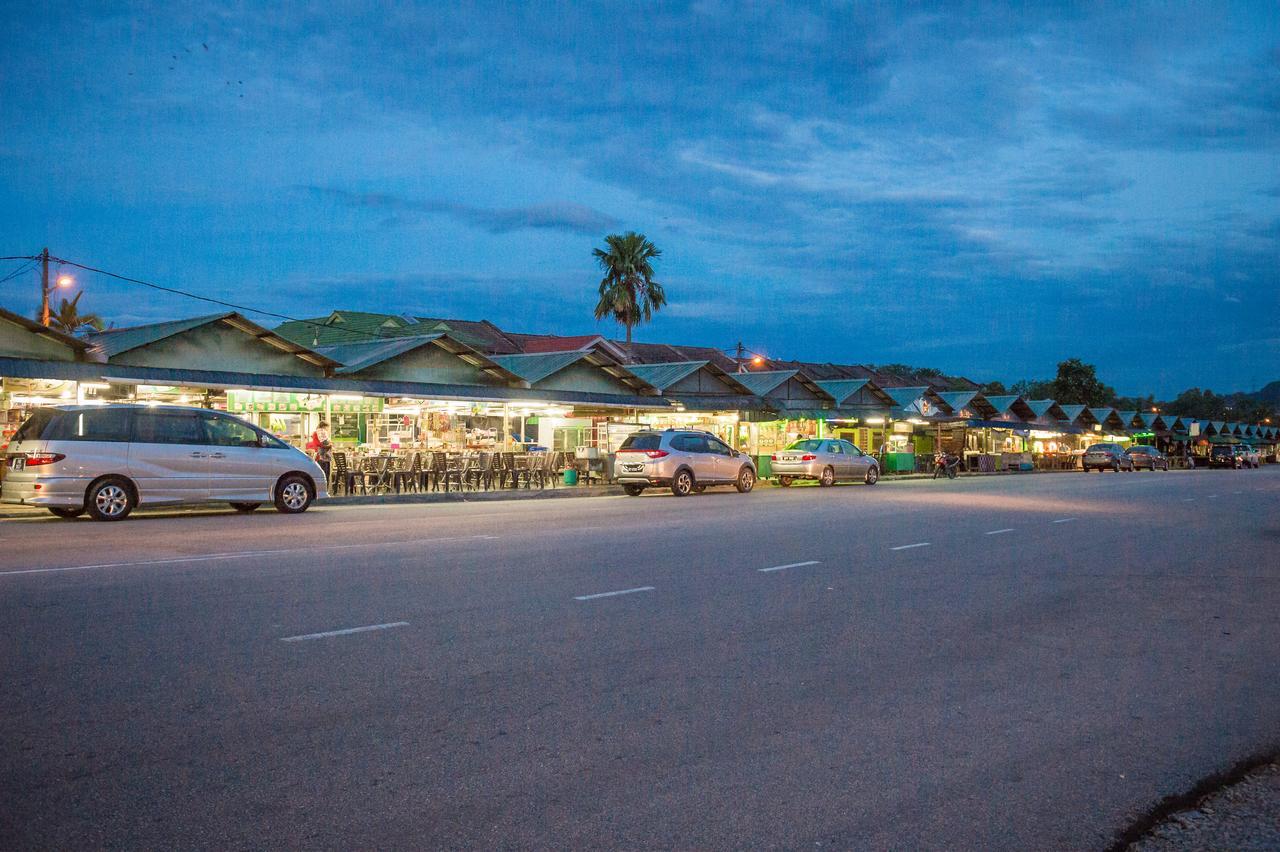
[0,467,1280,849]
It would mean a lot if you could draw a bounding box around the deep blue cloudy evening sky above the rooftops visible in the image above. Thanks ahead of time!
[0,0,1280,397]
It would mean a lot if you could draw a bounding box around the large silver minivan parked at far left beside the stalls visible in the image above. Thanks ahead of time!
[0,406,328,521]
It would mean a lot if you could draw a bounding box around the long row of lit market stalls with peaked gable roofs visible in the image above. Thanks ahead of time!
[0,308,1280,476]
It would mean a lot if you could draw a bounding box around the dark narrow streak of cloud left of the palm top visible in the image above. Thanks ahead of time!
[298,185,621,237]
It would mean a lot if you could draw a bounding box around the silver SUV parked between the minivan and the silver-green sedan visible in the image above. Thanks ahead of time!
[613,429,755,496]
